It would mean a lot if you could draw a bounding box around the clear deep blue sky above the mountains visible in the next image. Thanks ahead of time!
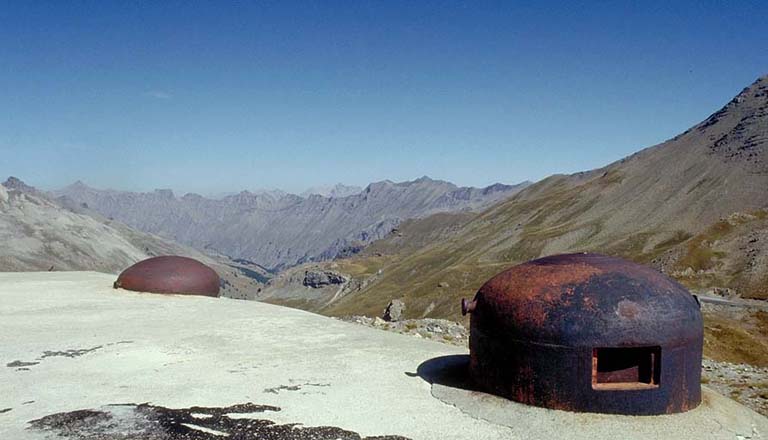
[0,0,768,194]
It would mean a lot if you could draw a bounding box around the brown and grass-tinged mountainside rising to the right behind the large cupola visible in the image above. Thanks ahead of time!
[260,77,768,319]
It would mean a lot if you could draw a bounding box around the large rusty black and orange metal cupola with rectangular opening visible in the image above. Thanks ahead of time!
[462,254,703,415]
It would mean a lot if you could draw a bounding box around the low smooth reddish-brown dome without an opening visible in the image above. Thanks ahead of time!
[114,256,219,296]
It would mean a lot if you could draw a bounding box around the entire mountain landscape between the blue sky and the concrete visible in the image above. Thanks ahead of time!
[6,77,768,332]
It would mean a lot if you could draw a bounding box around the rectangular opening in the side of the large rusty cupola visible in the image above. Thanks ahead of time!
[592,347,661,390]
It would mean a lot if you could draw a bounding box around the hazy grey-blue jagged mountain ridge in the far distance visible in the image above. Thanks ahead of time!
[53,176,528,269]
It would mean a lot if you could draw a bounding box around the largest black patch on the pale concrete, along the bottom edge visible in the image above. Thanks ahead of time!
[29,403,408,440]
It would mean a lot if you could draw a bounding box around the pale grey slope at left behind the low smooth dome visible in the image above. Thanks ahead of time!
[0,177,269,298]
